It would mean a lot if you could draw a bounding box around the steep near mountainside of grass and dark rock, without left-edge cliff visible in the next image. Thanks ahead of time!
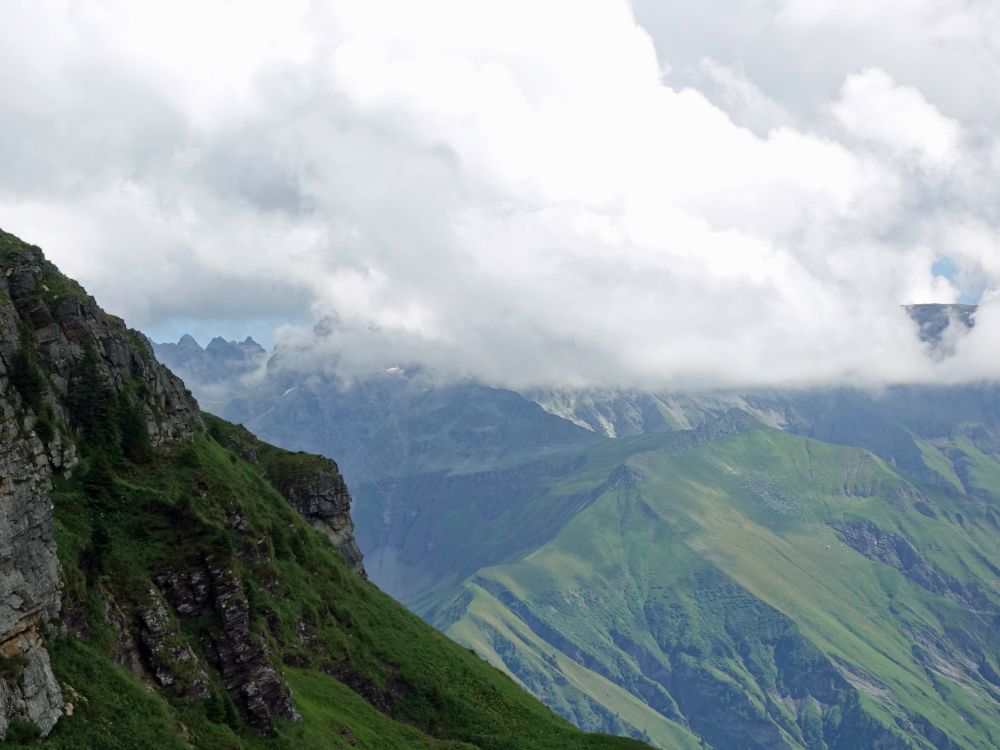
[0,228,640,750]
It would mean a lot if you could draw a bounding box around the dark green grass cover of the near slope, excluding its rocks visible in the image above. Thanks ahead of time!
[19,424,652,750]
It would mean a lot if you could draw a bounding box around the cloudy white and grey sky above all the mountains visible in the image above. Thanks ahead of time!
[0,0,1000,388]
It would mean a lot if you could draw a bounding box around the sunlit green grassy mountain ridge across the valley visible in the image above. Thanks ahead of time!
[440,426,1000,750]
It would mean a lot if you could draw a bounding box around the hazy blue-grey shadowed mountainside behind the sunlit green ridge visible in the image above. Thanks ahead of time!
[215,373,601,597]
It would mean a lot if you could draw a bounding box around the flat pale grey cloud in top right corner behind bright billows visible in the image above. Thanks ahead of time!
[634,0,1000,129]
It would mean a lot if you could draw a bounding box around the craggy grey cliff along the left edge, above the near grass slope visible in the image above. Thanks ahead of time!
[0,235,201,736]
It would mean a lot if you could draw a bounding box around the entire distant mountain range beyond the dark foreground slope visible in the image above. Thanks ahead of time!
[154,306,1000,750]
